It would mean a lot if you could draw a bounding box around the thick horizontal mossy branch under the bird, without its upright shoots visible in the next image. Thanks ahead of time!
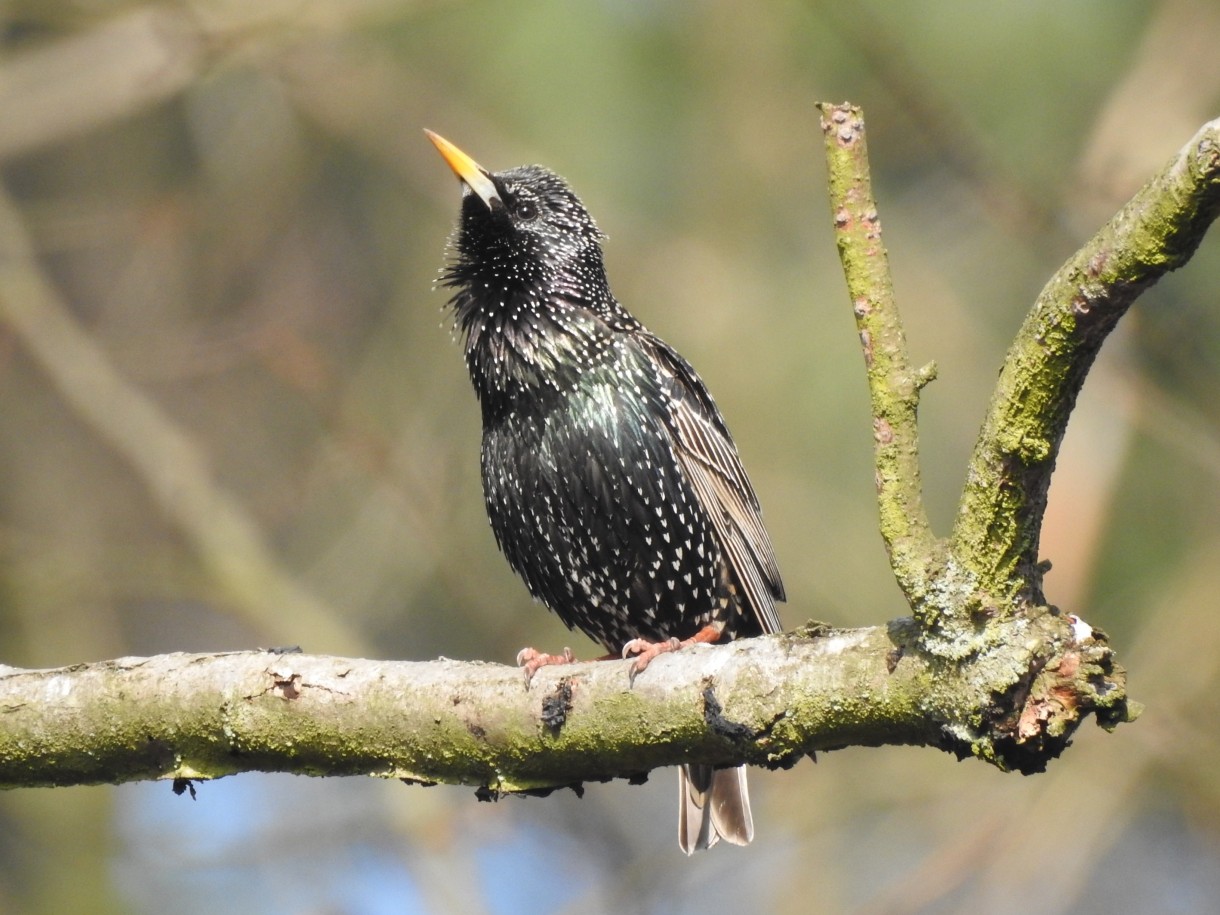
[0,619,1129,793]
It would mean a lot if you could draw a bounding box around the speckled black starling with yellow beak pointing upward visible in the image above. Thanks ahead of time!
[427,131,784,854]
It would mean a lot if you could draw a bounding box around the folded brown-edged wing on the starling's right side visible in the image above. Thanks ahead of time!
[650,337,784,632]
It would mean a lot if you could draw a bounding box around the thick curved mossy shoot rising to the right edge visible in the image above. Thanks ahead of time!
[952,120,1220,604]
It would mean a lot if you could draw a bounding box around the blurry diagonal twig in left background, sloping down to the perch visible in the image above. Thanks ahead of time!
[0,183,362,654]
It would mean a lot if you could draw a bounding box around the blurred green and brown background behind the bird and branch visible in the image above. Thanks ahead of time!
[0,0,1220,915]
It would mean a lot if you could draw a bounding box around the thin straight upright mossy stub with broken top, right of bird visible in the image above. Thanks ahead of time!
[819,104,943,606]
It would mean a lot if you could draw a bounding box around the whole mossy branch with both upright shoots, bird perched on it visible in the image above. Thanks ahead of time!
[0,105,1220,793]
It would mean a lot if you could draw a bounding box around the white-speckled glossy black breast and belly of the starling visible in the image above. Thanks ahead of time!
[470,360,725,650]
